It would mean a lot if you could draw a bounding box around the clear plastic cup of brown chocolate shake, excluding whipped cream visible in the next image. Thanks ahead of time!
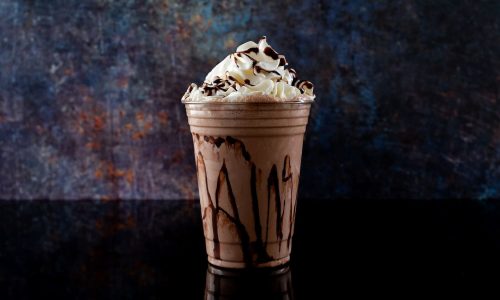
[185,102,311,268]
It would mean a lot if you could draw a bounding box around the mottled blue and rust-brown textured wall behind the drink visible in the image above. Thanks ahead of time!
[0,0,500,199]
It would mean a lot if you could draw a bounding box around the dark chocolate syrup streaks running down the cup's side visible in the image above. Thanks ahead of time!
[194,134,297,266]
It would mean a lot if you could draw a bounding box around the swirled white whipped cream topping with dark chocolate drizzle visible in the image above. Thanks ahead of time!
[182,36,315,102]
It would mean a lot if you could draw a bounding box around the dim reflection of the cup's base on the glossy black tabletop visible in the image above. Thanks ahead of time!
[205,265,294,300]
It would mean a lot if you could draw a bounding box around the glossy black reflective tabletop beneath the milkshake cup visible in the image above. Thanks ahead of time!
[0,199,500,299]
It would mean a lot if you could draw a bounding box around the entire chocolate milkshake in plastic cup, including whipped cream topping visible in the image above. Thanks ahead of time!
[183,37,314,268]
